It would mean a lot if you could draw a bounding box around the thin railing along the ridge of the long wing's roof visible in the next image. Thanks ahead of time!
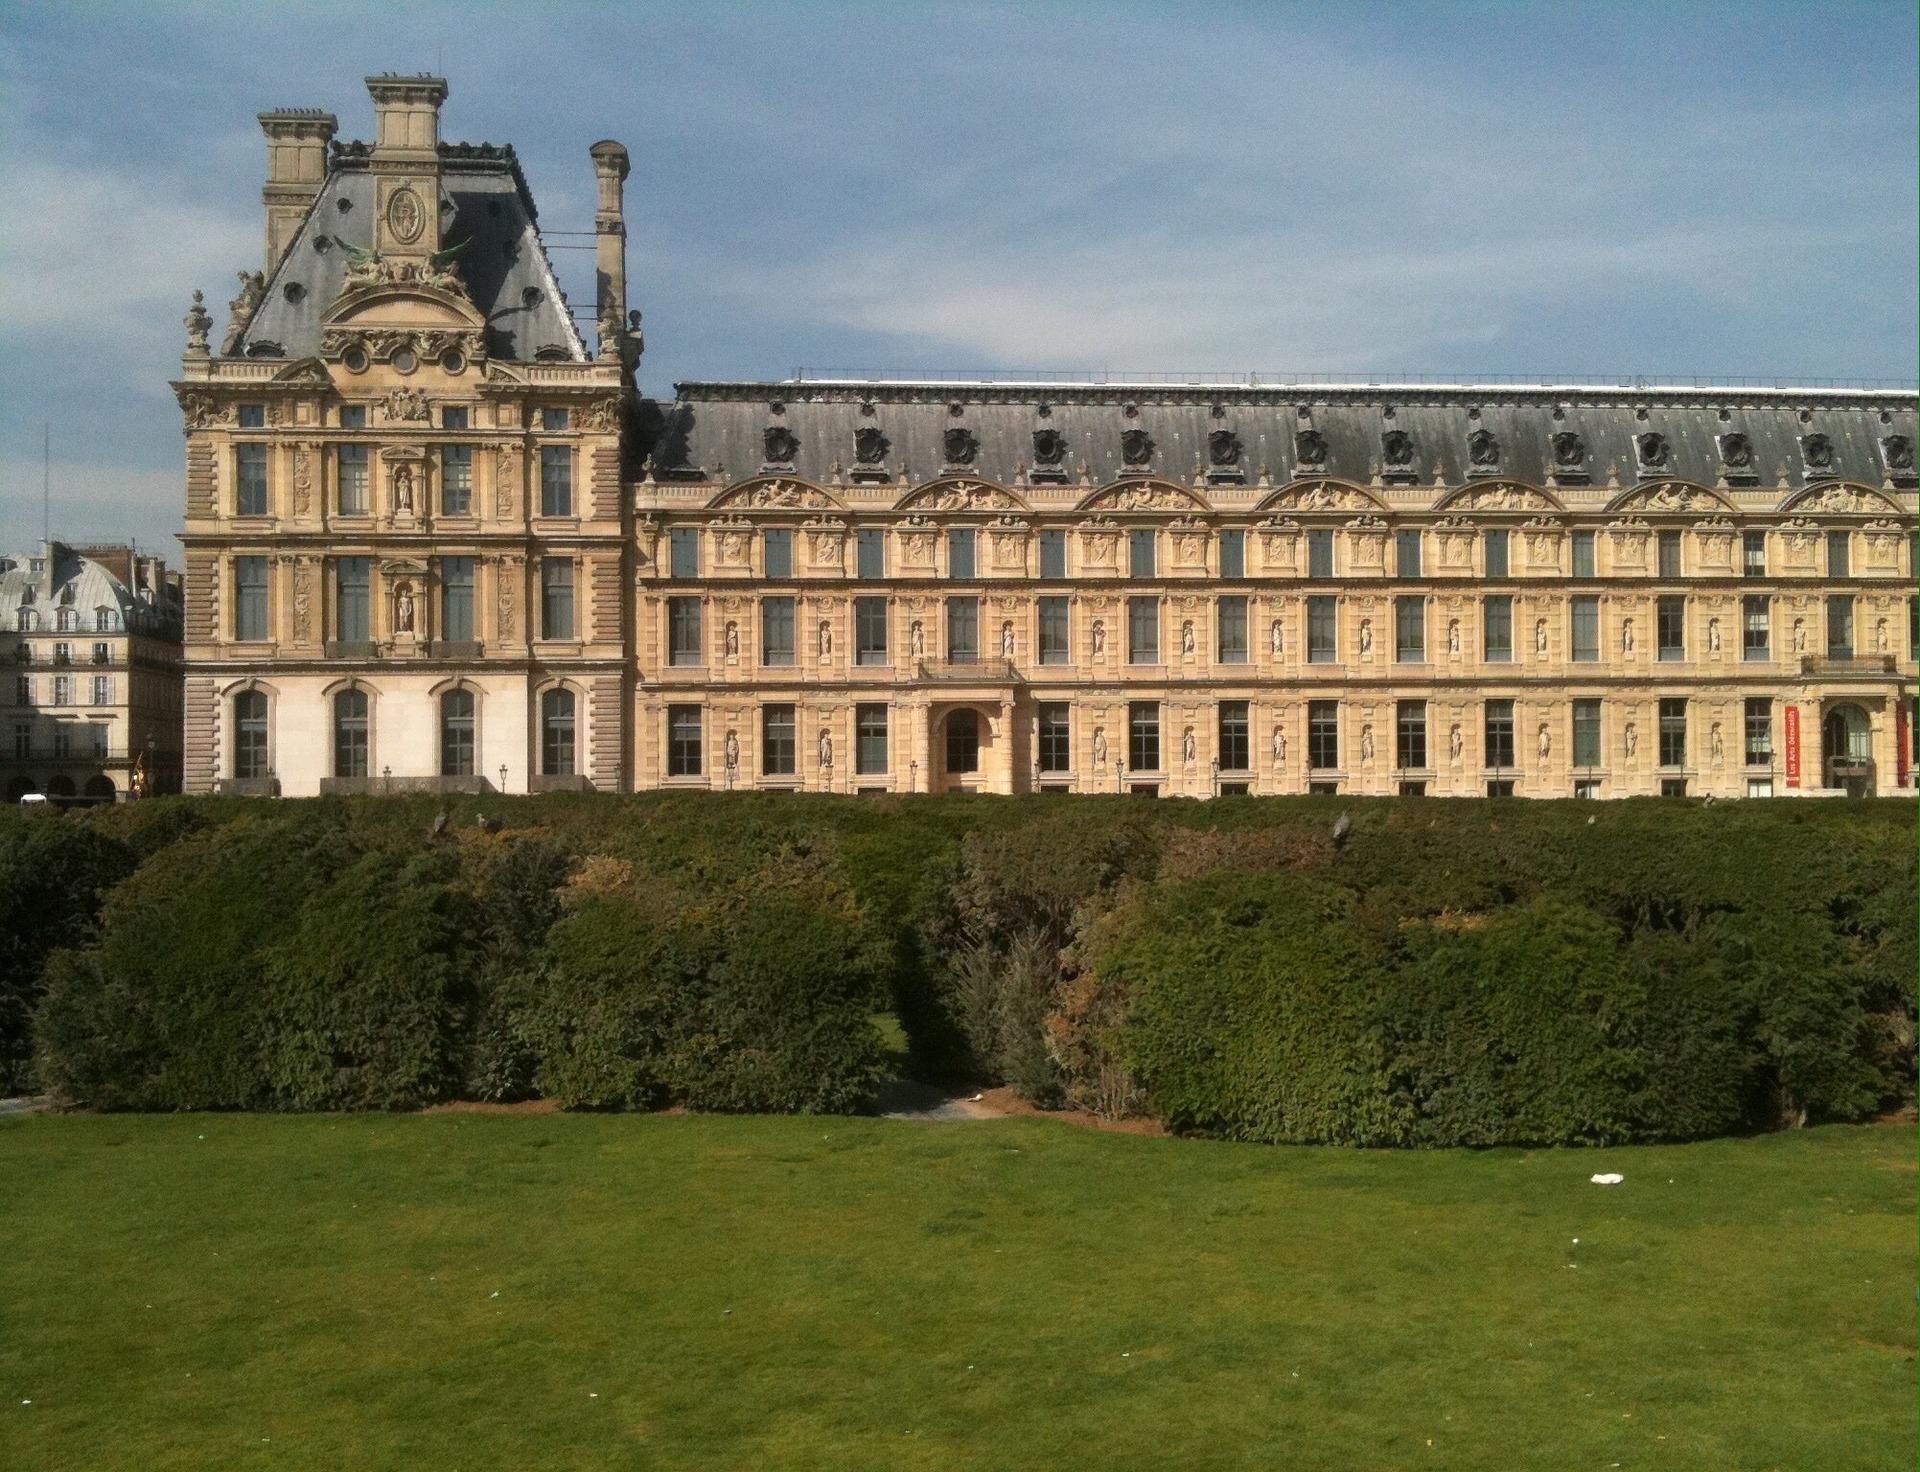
[783,367,1920,393]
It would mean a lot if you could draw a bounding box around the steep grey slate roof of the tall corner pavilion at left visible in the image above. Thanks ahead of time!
[238,142,588,363]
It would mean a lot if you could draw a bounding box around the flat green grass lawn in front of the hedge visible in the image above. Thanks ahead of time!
[0,1115,1914,1472]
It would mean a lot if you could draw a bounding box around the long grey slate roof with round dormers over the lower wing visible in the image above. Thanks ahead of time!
[649,380,1914,489]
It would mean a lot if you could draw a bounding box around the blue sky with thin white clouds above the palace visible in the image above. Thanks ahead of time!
[0,0,1920,555]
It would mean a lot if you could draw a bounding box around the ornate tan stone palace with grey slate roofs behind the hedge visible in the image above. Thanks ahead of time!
[177,77,1916,796]
